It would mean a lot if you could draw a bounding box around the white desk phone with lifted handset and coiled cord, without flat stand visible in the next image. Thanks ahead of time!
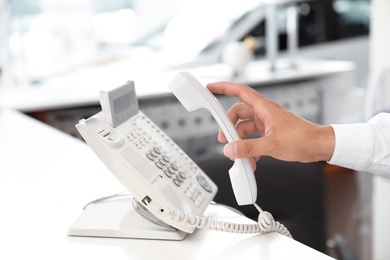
[69,72,290,238]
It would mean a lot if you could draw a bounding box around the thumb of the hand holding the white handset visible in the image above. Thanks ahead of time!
[223,138,266,159]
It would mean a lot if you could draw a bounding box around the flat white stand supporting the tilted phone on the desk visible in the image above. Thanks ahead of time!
[68,197,187,240]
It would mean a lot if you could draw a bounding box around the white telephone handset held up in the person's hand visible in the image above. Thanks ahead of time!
[169,72,257,205]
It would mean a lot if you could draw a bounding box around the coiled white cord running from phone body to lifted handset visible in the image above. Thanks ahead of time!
[160,203,292,237]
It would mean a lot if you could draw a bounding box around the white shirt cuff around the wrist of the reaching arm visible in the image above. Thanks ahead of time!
[328,124,373,171]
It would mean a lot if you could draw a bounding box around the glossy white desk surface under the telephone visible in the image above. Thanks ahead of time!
[0,109,336,260]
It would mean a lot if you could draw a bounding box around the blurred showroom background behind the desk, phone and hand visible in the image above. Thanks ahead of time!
[0,0,390,259]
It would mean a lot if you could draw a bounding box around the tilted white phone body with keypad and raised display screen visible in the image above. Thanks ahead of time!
[76,81,217,233]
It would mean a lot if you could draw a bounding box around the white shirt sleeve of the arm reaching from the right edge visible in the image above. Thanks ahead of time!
[328,113,390,174]
